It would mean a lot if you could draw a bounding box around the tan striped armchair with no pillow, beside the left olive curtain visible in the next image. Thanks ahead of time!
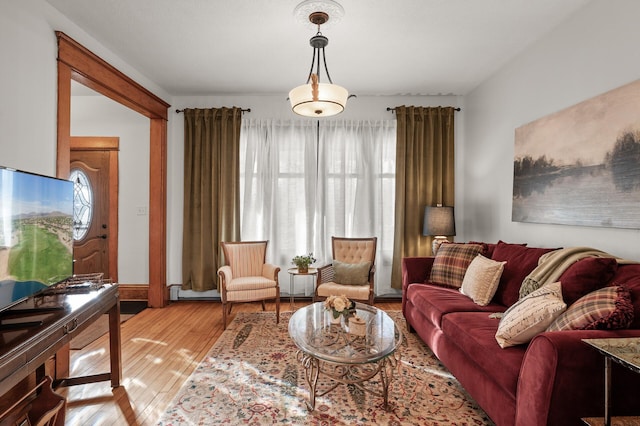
[218,241,280,329]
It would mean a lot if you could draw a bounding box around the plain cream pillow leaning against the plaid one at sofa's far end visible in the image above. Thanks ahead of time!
[460,254,507,306]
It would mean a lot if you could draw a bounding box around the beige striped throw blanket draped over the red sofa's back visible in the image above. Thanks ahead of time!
[520,247,625,299]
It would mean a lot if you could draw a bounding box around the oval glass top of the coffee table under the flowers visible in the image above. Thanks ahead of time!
[289,302,402,364]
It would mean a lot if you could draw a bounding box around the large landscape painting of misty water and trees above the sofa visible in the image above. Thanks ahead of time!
[512,80,640,229]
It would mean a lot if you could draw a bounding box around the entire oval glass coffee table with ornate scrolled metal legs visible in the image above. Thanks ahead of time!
[289,302,402,410]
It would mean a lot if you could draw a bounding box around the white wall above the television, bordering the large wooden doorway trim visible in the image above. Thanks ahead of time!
[0,0,170,176]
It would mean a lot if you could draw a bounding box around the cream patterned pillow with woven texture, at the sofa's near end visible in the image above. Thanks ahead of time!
[496,282,567,348]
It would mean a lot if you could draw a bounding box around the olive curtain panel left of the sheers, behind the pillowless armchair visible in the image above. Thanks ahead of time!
[182,107,242,291]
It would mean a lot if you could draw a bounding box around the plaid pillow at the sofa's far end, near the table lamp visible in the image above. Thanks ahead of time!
[429,243,484,288]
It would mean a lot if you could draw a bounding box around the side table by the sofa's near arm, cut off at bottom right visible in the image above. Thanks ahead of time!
[582,337,640,426]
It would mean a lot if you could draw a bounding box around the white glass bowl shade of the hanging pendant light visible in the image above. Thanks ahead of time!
[289,83,349,117]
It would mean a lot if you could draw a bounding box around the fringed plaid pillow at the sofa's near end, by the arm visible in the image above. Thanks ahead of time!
[547,286,633,331]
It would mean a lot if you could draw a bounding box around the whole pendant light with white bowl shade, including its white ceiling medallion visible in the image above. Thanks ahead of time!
[289,0,349,117]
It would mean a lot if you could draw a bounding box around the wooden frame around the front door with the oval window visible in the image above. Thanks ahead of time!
[69,136,120,282]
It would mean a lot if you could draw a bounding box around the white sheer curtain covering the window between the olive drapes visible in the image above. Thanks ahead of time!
[240,119,398,296]
